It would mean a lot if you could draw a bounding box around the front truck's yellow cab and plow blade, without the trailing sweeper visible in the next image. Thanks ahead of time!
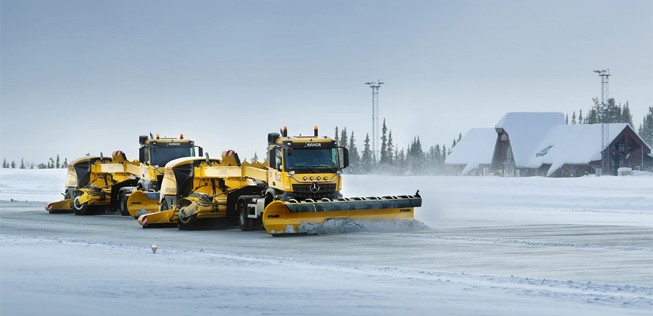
[238,127,422,236]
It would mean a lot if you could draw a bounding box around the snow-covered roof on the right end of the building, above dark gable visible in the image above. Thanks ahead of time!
[528,123,628,176]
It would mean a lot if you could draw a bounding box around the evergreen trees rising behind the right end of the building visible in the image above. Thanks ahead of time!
[566,98,653,145]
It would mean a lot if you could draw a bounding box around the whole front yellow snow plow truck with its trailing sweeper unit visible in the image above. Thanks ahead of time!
[139,127,422,236]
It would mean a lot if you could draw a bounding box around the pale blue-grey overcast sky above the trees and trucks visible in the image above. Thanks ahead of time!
[0,0,653,163]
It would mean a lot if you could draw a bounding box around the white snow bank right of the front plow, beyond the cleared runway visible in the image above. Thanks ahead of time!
[343,175,653,228]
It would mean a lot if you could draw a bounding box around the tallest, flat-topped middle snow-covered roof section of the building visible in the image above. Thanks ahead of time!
[495,112,565,168]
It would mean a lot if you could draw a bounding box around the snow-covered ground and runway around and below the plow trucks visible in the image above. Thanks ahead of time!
[0,169,653,315]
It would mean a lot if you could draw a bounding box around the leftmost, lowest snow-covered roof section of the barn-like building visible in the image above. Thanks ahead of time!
[446,128,497,175]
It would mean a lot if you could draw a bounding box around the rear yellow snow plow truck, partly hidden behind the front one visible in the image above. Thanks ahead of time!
[46,135,202,215]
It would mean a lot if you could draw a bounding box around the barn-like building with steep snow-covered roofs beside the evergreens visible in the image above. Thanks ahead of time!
[446,112,653,177]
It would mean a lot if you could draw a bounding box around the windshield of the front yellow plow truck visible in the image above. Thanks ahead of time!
[286,148,339,172]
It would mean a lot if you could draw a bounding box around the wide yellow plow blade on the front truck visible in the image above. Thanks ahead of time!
[263,195,422,236]
